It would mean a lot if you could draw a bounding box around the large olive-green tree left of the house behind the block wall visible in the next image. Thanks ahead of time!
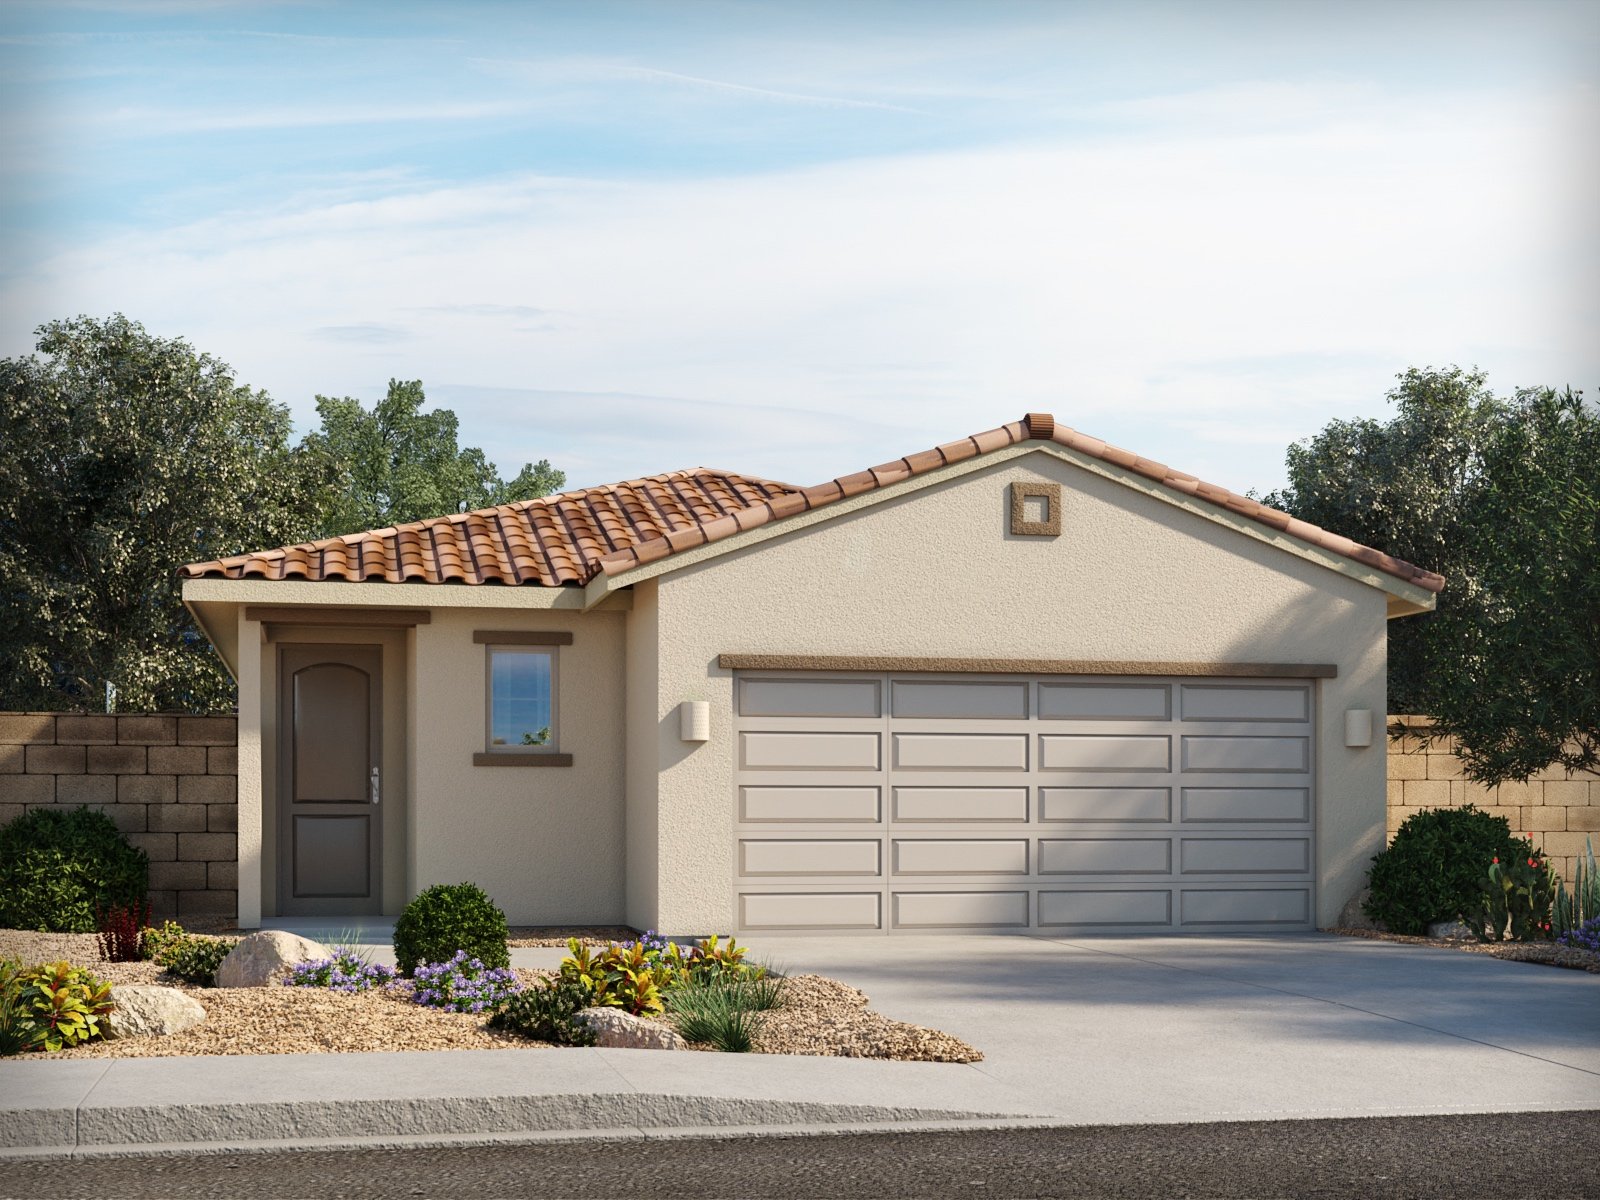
[0,314,334,710]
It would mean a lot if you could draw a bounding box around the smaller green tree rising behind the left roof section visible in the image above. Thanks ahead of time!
[306,379,566,536]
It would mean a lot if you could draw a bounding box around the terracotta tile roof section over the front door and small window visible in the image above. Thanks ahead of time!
[178,467,797,587]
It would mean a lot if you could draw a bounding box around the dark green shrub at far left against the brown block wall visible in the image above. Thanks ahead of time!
[0,808,150,933]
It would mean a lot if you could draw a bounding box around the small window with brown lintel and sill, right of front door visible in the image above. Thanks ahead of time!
[472,630,573,766]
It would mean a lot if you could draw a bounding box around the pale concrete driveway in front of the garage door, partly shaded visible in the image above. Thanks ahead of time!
[755,934,1600,1123]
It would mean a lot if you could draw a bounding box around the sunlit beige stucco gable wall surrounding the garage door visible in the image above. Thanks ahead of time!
[629,451,1386,933]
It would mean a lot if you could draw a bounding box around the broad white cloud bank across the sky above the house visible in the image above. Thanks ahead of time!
[0,82,1600,499]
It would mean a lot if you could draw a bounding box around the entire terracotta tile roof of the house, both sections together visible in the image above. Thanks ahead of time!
[179,413,1445,592]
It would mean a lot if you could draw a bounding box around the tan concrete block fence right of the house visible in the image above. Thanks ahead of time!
[1389,717,1600,882]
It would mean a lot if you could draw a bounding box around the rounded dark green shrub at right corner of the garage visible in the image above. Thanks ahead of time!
[1363,805,1533,936]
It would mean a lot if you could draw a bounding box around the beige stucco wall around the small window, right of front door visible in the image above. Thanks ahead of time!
[408,610,624,925]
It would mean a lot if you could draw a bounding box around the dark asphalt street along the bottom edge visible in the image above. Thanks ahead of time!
[0,1110,1600,1200]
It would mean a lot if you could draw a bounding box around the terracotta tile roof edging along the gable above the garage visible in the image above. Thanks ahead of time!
[600,413,1445,592]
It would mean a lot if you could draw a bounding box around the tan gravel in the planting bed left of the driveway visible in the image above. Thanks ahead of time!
[0,930,982,1062]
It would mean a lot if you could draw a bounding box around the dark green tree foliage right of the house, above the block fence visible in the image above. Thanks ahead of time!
[1262,368,1600,784]
